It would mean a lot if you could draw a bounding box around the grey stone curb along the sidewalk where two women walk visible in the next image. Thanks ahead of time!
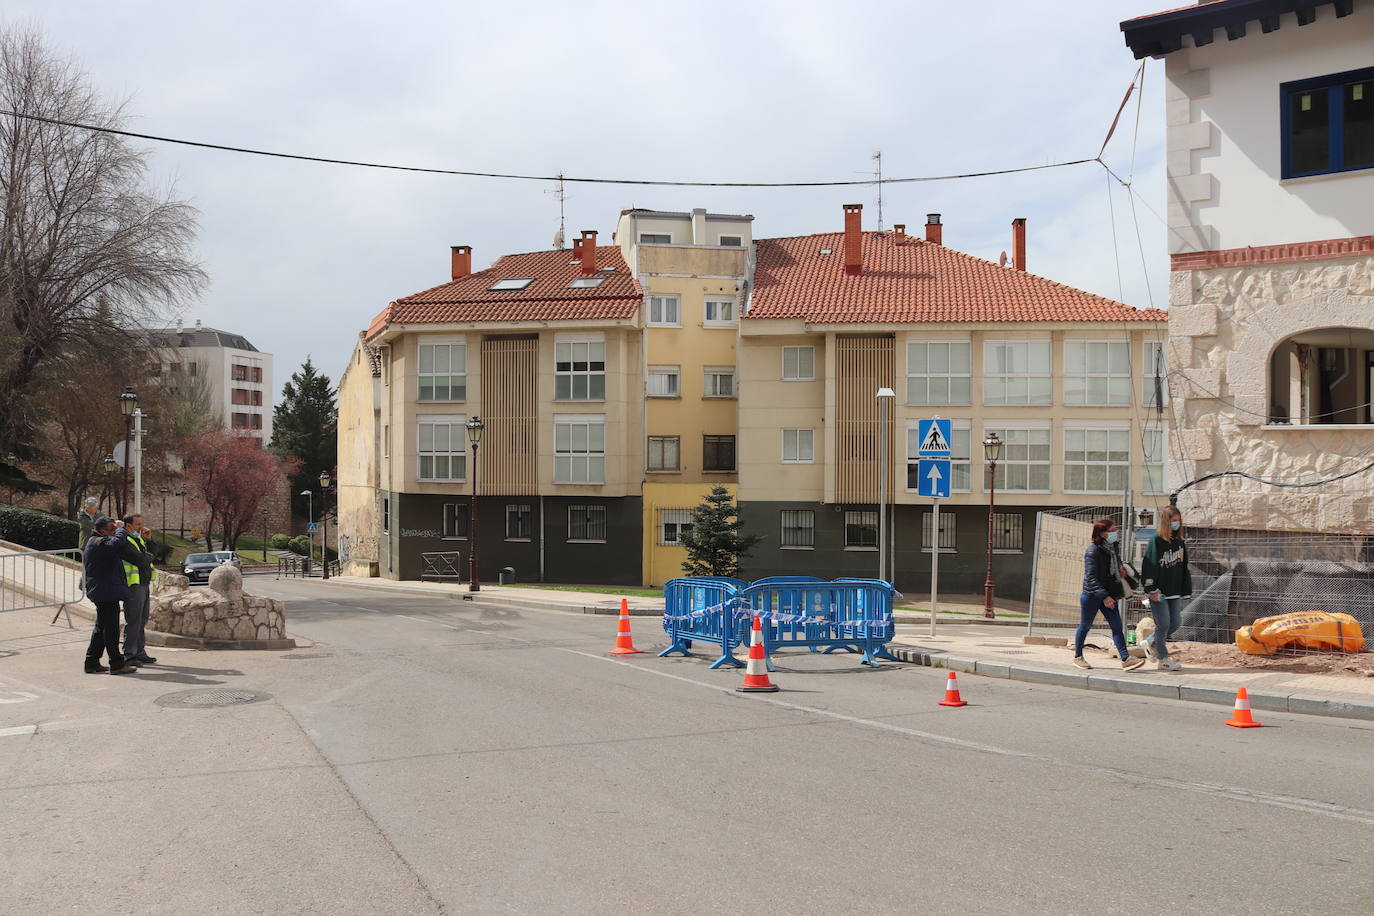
[888,643,1374,721]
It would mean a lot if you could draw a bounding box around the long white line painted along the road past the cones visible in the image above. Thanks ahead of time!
[558,648,1374,825]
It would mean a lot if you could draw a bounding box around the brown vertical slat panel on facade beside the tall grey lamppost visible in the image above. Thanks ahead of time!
[835,335,897,504]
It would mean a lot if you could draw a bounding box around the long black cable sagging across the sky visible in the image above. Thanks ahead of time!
[0,110,1098,188]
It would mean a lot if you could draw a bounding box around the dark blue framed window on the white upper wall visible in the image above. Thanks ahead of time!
[1279,67,1374,179]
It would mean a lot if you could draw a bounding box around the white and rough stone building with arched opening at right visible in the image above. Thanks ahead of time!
[1121,0,1374,533]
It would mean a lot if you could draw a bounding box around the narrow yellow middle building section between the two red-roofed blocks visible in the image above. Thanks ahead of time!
[616,209,753,585]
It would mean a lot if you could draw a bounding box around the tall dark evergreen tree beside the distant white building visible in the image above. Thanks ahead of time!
[271,357,338,515]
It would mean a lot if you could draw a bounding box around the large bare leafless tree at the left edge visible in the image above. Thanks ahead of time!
[0,27,205,469]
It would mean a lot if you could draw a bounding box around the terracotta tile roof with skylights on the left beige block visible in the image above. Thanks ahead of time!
[367,244,644,339]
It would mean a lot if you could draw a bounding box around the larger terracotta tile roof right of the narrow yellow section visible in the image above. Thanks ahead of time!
[745,232,1168,324]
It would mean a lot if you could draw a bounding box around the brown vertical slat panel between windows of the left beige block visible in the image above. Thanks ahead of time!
[480,336,539,496]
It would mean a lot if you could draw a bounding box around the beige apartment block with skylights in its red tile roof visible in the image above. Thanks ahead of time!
[339,231,644,585]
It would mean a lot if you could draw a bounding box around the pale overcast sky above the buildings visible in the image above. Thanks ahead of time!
[13,0,1169,390]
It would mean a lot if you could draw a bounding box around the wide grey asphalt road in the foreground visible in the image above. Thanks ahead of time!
[0,578,1374,915]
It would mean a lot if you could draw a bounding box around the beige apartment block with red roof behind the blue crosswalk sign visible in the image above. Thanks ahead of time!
[736,205,1167,599]
